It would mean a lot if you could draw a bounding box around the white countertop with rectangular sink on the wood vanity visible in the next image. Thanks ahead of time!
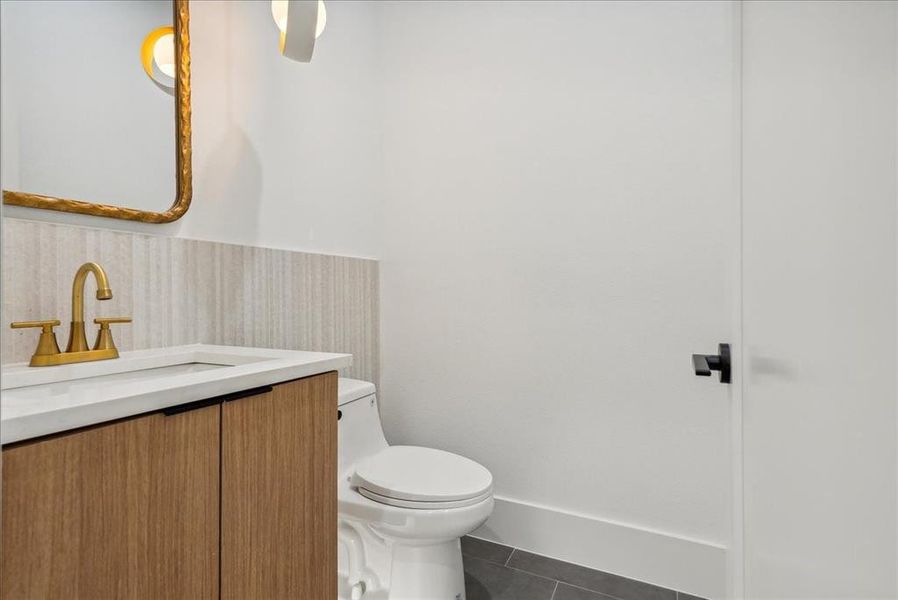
[0,344,352,444]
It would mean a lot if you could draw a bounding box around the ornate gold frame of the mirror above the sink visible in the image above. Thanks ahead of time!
[3,0,193,223]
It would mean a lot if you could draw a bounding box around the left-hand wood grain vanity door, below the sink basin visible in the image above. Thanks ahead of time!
[0,405,221,600]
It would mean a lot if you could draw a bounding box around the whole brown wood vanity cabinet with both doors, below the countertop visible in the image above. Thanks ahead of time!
[0,373,337,600]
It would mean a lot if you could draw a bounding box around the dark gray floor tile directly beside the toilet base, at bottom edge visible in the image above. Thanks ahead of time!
[464,556,555,600]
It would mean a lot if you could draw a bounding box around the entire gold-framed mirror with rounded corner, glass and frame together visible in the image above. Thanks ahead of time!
[3,0,193,223]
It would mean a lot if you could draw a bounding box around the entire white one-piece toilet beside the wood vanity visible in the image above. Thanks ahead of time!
[338,379,493,600]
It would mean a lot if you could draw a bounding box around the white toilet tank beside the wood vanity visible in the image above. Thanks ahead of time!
[337,377,387,476]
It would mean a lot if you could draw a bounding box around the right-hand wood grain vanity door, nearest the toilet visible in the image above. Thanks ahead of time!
[221,373,337,600]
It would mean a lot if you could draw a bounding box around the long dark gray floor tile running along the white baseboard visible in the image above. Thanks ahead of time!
[508,550,677,600]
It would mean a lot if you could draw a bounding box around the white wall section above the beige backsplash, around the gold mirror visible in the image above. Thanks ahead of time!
[4,1,381,257]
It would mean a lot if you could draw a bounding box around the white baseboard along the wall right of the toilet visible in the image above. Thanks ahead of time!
[471,497,727,598]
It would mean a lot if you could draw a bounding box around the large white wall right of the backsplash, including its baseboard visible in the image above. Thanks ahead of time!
[381,2,738,595]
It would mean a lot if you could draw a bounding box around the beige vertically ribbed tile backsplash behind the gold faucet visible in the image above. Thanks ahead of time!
[0,218,379,381]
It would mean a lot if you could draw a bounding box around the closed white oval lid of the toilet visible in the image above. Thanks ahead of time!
[353,446,493,502]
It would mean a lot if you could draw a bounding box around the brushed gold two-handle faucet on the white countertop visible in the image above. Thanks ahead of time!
[11,262,131,367]
